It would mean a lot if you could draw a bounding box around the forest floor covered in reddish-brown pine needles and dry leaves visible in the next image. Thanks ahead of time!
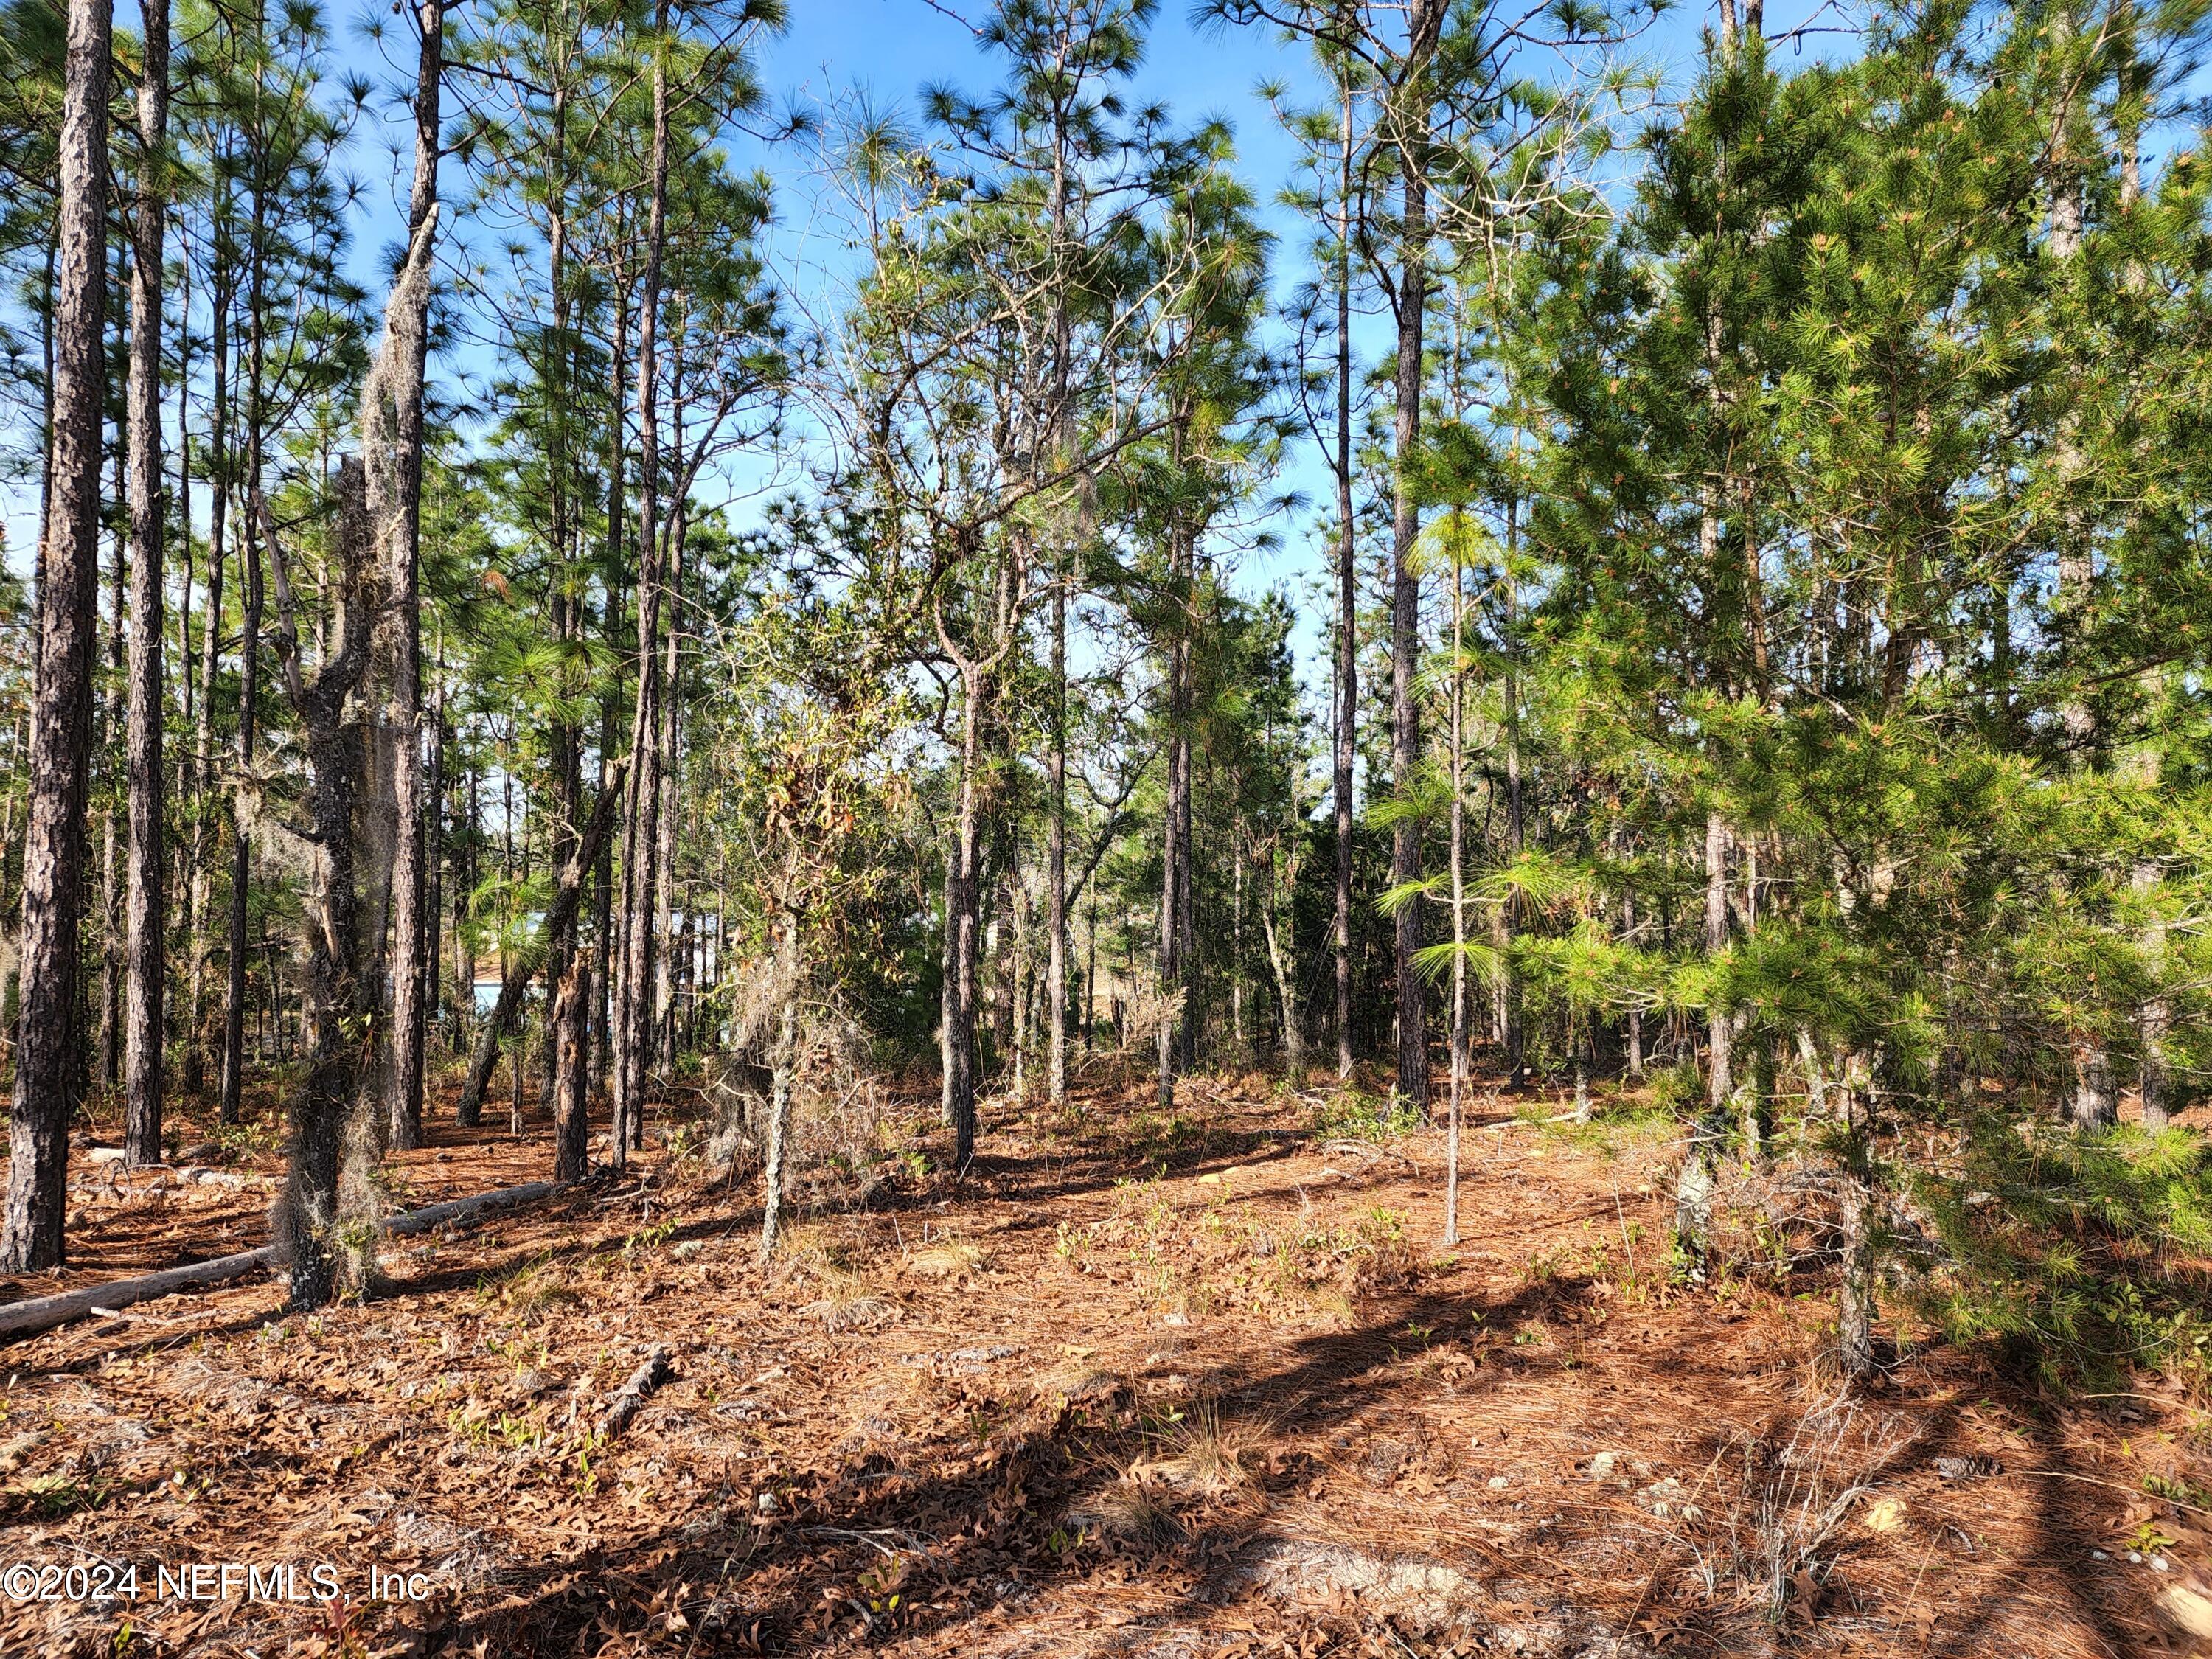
[0,1073,2212,1659]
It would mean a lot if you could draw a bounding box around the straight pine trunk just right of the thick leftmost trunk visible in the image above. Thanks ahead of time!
[124,0,168,1164]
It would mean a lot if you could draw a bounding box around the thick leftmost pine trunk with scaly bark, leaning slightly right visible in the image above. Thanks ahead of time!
[0,0,113,1272]
